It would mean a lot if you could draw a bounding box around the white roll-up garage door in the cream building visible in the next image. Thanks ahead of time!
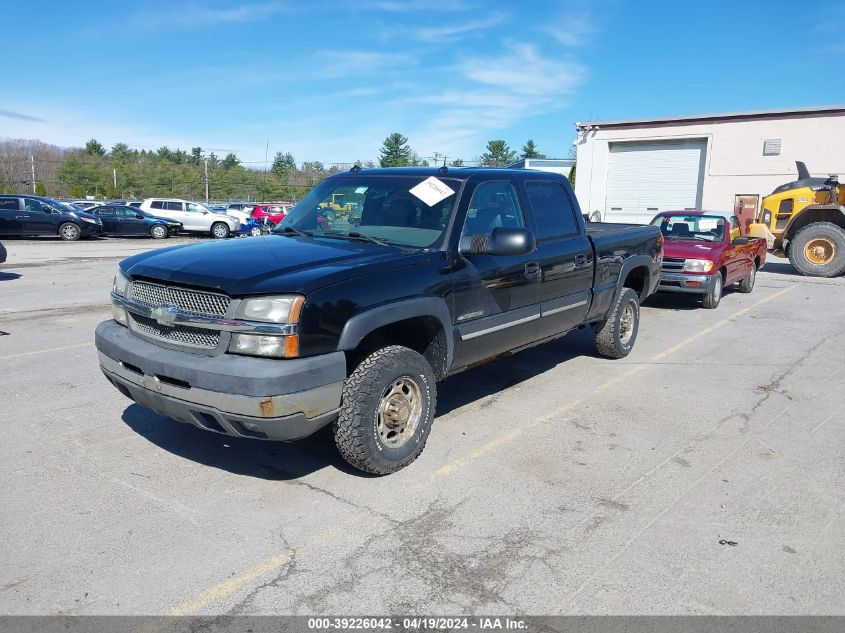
[602,139,707,224]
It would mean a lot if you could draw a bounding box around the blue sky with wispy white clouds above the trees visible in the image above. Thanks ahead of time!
[0,0,845,163]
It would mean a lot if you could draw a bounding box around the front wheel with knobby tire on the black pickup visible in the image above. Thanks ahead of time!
[334,345,437,475]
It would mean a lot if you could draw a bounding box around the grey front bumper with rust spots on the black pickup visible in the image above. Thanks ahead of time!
[95,321,346,441]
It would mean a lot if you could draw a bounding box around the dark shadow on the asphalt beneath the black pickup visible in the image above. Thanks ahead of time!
[122,329,596,481]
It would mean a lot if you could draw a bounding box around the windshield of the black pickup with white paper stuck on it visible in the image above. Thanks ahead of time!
[274,175,460,248]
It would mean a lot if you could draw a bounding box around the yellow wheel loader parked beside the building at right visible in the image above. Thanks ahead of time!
[757,161,845,277]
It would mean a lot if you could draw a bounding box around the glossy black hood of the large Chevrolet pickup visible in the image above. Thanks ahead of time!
[120,235,420,297]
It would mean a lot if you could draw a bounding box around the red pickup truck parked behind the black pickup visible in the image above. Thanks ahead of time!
[651,211,766,308]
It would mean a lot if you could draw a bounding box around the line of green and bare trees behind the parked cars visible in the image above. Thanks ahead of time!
[0,132,572,201]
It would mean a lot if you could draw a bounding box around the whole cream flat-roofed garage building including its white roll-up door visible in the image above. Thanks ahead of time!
[575,106,845,223]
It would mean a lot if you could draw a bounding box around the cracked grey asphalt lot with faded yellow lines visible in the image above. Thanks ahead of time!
[0,238,845,615]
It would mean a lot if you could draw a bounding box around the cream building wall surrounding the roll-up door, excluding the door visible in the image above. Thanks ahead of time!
[575,114,845,221]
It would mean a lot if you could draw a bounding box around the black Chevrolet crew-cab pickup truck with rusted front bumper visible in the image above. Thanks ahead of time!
[96,167,663,474]
